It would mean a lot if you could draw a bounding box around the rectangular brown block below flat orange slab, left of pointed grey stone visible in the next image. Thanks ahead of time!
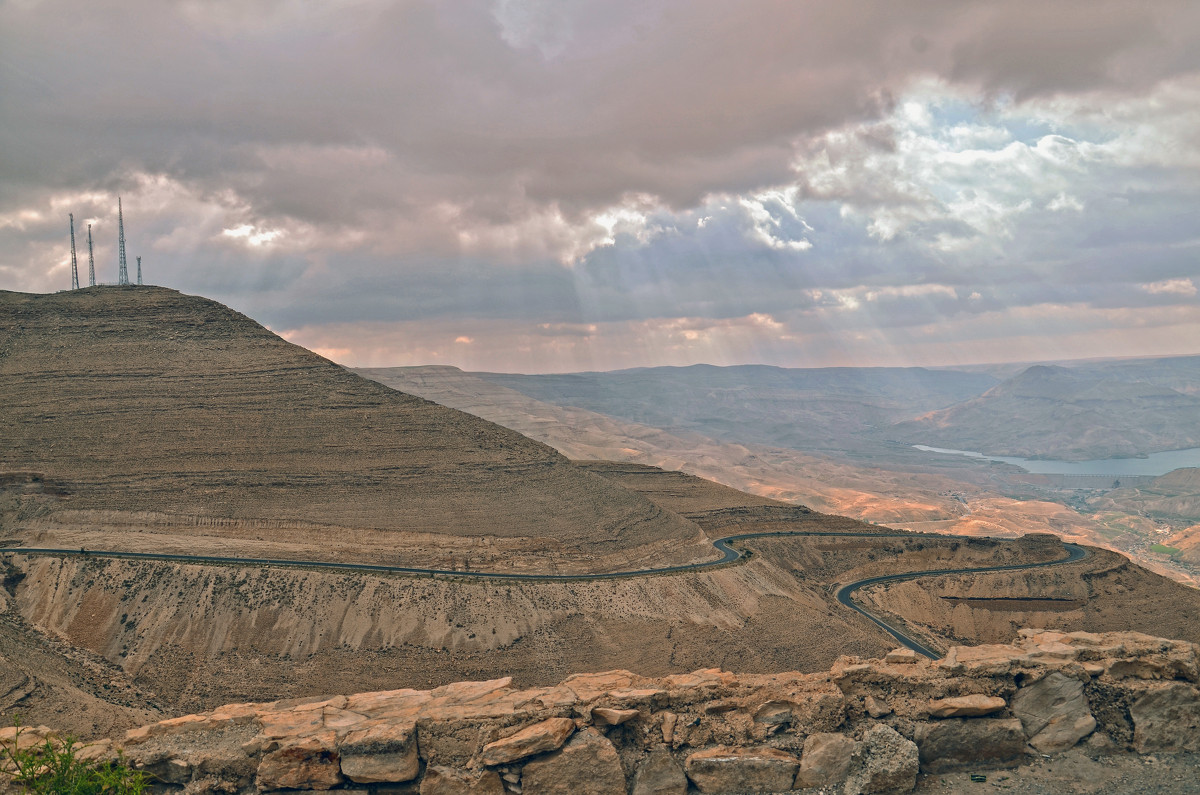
[916,718,1025,773]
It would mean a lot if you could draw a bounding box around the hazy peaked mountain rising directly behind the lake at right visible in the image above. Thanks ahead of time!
[887,365,1200,460]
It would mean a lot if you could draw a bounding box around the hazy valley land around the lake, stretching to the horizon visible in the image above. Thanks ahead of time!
[359,357,1200,585]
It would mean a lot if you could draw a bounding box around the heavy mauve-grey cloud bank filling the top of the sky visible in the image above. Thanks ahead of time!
[0,0,1196,223]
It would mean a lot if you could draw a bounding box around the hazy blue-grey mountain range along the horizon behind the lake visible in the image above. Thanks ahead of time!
[458,357,1200,460]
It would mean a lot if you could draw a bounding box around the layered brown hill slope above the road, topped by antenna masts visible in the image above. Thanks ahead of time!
[0,287,710,566]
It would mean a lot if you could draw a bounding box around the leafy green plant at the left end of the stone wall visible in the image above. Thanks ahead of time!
[0,722,146,795]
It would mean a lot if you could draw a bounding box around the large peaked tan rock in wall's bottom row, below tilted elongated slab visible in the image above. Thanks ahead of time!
[521,729,625,795]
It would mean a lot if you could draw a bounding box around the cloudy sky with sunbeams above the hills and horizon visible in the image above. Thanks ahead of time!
[0,0,1200,372]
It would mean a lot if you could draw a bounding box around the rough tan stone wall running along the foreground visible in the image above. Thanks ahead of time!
[8,630,1200,795]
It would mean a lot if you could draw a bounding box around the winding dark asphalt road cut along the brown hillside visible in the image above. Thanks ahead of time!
[0,531,1088,659]
